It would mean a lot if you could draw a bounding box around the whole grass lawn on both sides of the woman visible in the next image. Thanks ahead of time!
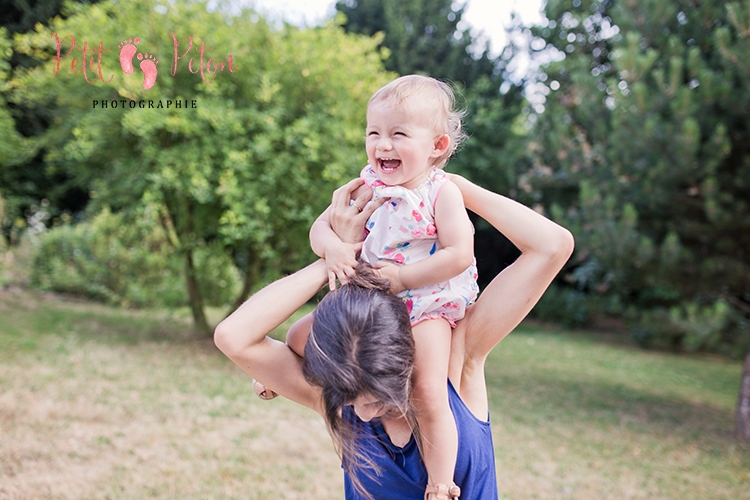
[0,289,750,500]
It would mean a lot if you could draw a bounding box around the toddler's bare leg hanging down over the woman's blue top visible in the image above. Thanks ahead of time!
[412,319,458,494]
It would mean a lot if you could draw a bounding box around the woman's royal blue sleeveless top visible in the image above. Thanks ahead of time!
[343,381,498,500]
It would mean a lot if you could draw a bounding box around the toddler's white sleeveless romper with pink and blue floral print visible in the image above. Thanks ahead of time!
[360,165,479,328]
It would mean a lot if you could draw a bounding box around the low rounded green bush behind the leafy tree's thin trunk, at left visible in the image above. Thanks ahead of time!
[30,210,239,307]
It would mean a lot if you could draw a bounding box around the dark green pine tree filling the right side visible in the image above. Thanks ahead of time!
[532,0,750,354]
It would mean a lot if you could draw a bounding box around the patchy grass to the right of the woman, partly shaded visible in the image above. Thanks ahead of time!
[487,328,750,500]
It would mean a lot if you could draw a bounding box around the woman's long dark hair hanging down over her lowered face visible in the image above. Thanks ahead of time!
[302,263,418,496]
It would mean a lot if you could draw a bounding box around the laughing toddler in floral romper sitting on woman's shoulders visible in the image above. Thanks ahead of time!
[308,75,478,492]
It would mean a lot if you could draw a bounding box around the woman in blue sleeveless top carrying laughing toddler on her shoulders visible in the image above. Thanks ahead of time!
[215,176,573,500]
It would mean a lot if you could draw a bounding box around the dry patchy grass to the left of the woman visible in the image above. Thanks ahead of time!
[0,292,342,500]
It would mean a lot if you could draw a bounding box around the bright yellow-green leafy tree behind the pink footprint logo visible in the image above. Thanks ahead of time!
[12,0,385,330]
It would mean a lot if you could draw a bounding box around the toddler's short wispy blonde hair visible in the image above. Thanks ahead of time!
[367,75,466,168]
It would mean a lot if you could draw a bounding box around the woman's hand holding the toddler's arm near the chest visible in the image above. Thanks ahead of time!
[328,178,388,243]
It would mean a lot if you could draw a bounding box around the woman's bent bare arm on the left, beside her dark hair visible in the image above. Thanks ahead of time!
[214,260,328,413]
